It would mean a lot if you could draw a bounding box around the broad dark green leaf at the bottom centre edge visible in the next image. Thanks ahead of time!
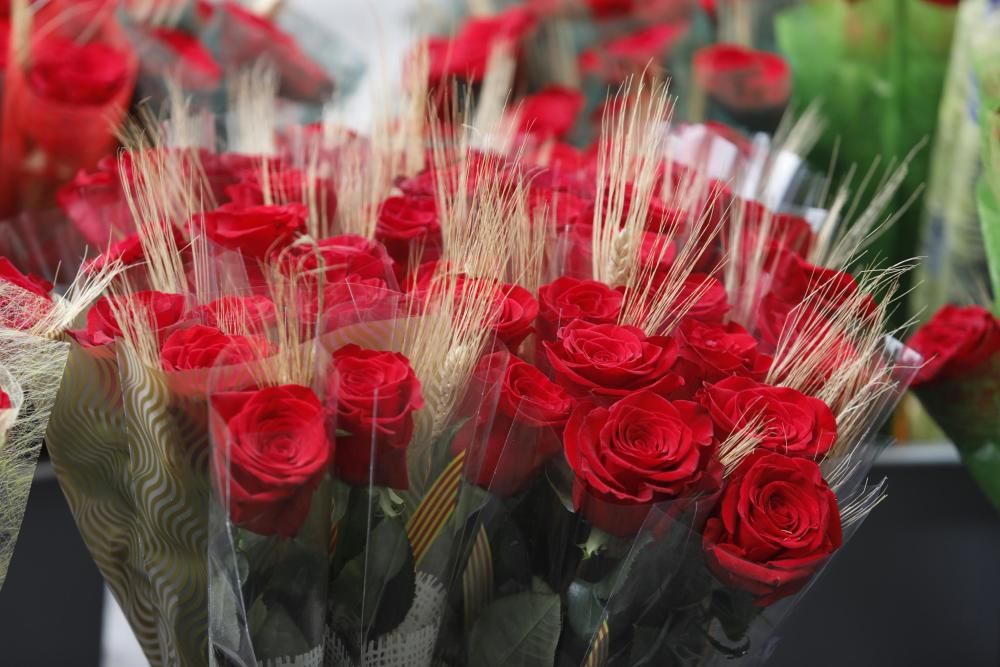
[468,593,562,667]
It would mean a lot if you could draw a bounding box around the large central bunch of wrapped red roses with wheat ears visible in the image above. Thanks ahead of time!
[0,40,915,666]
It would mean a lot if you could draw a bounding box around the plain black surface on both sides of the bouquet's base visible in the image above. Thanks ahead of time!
[0,456,1000,667]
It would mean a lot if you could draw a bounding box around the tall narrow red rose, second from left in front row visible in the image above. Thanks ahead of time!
[330,345,424,489]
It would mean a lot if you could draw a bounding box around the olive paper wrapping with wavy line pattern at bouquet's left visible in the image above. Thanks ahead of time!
[47,346,208,667]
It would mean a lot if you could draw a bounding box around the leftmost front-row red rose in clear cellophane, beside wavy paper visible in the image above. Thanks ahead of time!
[211,385,333,537]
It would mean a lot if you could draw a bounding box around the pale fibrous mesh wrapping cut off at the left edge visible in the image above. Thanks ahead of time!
[0,330,69,587]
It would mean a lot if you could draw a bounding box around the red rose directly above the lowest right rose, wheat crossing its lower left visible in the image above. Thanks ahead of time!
[700,376,837,459]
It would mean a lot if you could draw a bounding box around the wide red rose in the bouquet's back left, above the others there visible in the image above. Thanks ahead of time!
[202,204,307,259]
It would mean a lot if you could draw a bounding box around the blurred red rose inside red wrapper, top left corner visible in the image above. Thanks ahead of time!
[28,36,129,106]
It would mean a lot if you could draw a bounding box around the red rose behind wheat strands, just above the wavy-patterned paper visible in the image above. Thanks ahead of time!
[74,290,185,347]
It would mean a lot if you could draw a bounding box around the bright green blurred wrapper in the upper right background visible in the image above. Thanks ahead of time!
[775,0,956,280]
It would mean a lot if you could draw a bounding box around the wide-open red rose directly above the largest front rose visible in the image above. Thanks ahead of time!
[544,320,684,403]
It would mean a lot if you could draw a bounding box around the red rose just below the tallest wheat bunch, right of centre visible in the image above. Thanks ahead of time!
[538,276,624,340]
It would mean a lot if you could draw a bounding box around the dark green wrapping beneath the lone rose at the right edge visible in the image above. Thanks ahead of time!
[916,352,1000,509]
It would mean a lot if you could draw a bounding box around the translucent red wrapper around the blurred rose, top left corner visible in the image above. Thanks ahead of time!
[0,0,139,217]
